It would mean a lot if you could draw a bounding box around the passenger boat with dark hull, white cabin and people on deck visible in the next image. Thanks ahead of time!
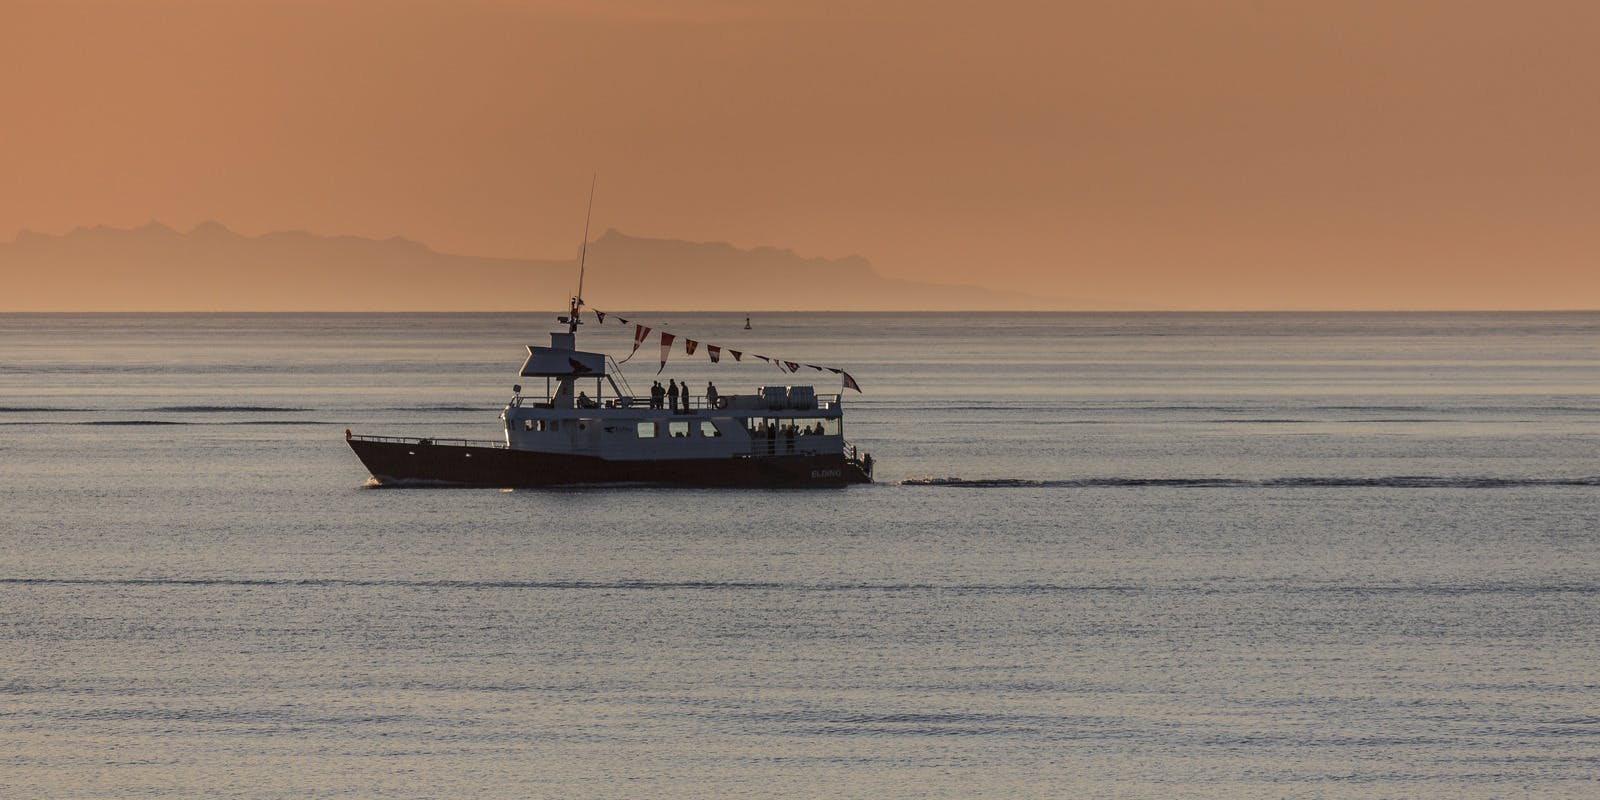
[344,299,874,488]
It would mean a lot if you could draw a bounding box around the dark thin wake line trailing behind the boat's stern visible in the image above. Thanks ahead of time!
[899,475,1600,490]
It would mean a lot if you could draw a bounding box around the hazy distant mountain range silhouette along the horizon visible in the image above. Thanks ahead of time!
[0,222,1098,310]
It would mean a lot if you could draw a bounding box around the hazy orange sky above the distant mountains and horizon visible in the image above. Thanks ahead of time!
[0,0,1600,309]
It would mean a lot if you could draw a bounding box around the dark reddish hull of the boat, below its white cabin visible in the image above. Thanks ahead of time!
[347,437,872,488]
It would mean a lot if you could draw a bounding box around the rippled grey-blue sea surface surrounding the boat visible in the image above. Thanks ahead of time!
[0,312,1600,798]
